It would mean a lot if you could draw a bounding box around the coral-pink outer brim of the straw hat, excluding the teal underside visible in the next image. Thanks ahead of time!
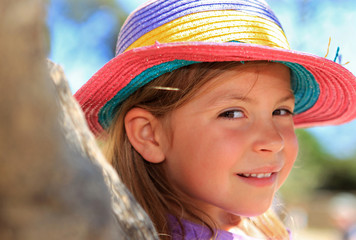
[74,42,356,135]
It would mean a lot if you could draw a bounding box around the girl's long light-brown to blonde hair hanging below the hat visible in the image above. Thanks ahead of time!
[104,62,288,240]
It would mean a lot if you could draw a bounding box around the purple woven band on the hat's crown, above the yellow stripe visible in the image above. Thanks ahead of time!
[116,0,282,55]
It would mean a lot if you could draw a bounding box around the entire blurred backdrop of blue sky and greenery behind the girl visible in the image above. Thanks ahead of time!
[47,0,356,240]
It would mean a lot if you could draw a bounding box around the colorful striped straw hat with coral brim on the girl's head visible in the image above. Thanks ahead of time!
[75,0,356,135]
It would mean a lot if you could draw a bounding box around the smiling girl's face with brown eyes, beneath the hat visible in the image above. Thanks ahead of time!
[160,63,298,228]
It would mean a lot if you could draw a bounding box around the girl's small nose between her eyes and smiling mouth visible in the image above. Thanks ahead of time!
[254,123,284,153]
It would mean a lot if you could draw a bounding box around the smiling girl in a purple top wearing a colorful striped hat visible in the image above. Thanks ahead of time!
[75,0,356,239]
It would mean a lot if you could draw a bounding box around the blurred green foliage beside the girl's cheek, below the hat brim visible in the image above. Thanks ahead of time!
[280,130,356,202]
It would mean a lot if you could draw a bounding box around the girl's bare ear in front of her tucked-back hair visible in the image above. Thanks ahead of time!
[125,108,165,163]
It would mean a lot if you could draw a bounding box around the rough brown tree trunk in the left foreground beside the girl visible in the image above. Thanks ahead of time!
[0,0,157,240]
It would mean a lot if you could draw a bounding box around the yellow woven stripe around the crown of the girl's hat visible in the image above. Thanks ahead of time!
[126,10,290,51]
